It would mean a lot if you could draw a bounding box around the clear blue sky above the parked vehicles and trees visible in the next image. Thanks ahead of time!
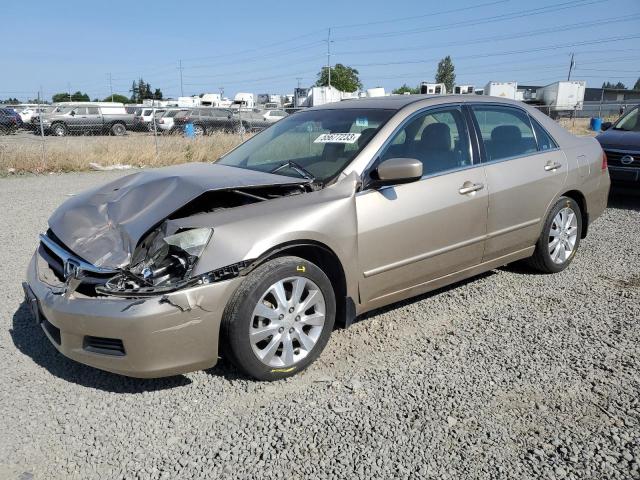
[0,0,640,99]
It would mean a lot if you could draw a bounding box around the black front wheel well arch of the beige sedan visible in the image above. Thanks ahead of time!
[260,242,355,326]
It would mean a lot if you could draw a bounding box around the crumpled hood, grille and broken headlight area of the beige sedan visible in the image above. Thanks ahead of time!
[42,164,313,298]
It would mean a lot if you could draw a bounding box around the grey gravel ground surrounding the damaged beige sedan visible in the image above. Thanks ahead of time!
[0,173,640,480]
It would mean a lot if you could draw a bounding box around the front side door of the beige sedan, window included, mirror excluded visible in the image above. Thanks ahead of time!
[356,106,488,302]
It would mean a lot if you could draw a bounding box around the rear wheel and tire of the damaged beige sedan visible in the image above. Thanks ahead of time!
[527,197,582,273]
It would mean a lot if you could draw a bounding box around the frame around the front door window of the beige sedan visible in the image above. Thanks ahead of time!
[361,103,482,184]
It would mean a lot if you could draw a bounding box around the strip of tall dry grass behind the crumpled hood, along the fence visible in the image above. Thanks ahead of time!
[0,133,246,175]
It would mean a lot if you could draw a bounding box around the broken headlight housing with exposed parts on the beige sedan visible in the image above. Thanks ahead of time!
[96,228,213,295]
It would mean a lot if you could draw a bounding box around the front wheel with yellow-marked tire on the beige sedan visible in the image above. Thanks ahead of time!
[220,257,336,381]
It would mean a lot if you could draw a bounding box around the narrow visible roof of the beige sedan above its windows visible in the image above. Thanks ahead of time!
[311,94,536,110]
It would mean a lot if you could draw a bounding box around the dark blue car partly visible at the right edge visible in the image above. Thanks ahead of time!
[596,105,640,189]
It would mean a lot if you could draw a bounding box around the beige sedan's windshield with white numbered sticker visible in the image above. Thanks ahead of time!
[218,108,395,183]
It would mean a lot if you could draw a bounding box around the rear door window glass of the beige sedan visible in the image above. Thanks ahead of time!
[472,105,538,161]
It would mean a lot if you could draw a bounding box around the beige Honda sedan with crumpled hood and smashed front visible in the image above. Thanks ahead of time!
[24,95,609,380]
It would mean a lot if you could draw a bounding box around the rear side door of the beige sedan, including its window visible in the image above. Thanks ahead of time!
[471,104,568,261]
